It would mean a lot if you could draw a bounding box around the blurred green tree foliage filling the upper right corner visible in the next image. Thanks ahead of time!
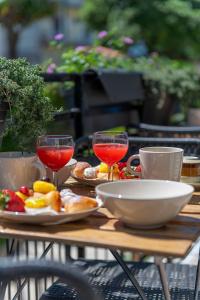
[82,0,200,60]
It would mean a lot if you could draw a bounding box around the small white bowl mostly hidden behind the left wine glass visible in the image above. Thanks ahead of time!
[47,158,77,185]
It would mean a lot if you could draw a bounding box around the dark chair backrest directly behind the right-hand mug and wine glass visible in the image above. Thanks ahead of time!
[75,136,200,165]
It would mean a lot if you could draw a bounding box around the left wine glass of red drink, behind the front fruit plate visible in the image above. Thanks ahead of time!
[36,135,74,187]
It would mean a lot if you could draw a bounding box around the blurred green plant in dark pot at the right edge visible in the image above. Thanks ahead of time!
[130,54,200,125]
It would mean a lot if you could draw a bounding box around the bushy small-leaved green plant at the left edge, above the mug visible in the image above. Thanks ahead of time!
[0,57,53,151]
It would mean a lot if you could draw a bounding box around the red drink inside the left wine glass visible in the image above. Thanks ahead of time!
[37,146,74,172]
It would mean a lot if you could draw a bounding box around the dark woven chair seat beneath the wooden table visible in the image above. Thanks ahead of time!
[40,260,200,300]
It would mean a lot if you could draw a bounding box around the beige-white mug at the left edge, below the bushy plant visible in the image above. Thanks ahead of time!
[0,152,46,190]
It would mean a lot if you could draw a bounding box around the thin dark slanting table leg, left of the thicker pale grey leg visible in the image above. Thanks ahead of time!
[110,249,147,300]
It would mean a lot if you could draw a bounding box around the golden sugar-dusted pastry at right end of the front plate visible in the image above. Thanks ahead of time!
[65,196,97,213]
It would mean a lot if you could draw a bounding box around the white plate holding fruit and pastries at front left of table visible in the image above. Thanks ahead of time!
[0,200,102,225]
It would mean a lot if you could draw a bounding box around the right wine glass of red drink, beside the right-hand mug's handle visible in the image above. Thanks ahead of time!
[92,131,128,180]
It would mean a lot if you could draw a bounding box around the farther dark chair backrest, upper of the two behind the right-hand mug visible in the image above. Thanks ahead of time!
[135,123,200,138]
